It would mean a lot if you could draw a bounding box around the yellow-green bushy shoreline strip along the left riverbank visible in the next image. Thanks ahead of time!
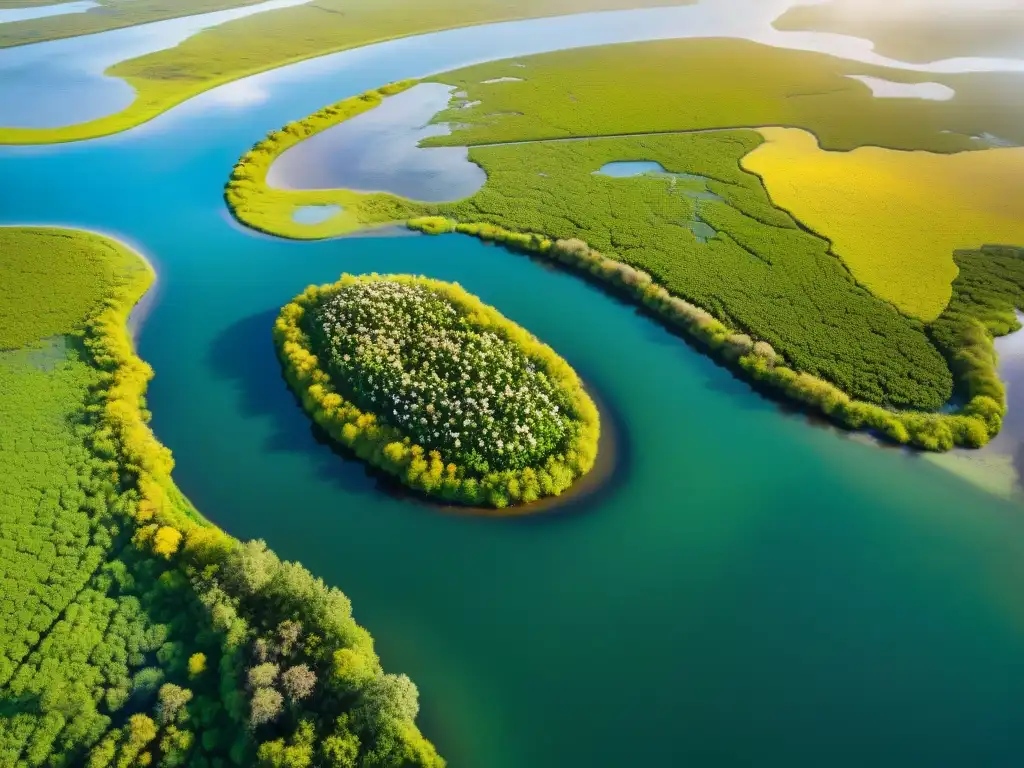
[5,226,444,768]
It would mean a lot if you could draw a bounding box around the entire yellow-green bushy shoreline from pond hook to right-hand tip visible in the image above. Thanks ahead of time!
[224,85,1007,452]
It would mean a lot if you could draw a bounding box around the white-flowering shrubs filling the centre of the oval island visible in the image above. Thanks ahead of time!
[315,280,579,474]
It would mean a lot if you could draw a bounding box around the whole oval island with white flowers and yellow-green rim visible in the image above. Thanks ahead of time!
[274,274,600,509]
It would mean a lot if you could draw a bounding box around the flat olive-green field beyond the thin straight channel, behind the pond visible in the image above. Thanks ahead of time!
[427,40,1024,152]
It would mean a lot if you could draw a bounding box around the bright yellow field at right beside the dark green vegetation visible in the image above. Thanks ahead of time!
[742,128,1024,322]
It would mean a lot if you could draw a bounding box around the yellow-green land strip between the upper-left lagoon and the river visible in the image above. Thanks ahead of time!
[0,0,693,144]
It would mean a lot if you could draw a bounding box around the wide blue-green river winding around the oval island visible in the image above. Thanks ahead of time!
[6,3,1024,768]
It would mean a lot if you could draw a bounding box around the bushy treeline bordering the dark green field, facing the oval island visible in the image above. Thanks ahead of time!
[410,217,1006,451]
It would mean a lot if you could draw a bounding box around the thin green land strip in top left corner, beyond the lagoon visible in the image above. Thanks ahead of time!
[0,0,263,48]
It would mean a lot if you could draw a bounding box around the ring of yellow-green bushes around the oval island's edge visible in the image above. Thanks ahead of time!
[273,275,600,508]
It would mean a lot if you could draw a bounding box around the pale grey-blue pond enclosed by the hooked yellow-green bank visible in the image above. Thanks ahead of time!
[267,83,487,203]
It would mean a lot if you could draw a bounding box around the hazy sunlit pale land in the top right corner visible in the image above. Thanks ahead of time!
[775,0,1024,61]
